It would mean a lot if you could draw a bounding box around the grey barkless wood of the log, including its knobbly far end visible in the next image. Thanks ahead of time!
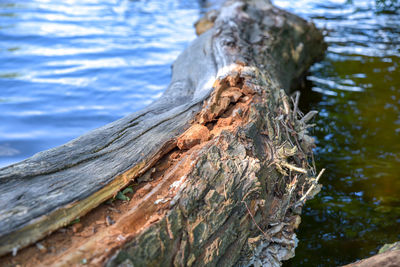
[0,0,323,262]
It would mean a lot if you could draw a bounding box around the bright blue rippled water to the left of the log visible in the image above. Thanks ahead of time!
[0,0,214,166]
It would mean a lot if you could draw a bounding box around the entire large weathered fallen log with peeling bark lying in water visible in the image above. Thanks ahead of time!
[0,0,325,266]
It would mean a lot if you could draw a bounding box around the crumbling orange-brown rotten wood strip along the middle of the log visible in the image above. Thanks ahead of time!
[0,70,253,266]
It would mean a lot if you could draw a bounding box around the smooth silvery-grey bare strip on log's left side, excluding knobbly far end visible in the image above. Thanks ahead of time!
[0,16,220,255]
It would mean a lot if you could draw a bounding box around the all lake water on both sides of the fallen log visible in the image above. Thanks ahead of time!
[0,0,400,266]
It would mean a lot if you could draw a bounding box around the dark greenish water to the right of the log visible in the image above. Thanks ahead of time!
[279,0,400,266]
